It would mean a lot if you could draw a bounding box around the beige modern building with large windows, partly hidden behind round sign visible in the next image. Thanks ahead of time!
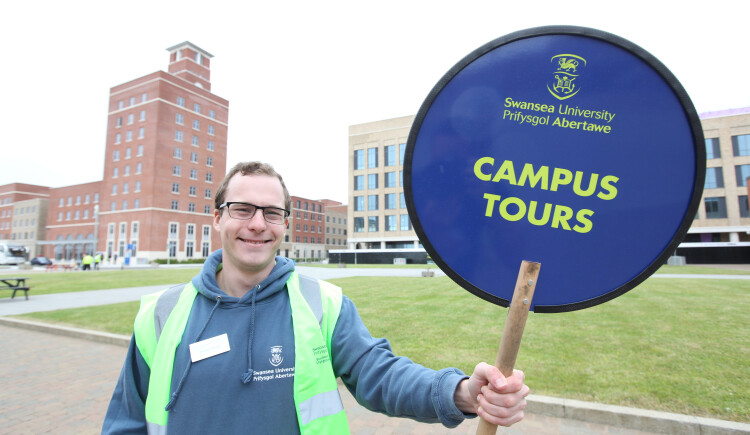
[350,107,750,264]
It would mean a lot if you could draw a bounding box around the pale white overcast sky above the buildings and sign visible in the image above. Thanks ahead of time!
[0,0,750,203]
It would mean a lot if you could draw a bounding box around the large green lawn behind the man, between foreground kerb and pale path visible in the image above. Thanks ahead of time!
[13,271,750,422]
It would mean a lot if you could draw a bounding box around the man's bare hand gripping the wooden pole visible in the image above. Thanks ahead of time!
[453,363,529,426]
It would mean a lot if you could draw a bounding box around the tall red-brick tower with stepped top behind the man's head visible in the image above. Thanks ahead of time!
[96,42,229,264]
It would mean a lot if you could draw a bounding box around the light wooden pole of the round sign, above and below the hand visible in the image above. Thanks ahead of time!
[477,260,541,435]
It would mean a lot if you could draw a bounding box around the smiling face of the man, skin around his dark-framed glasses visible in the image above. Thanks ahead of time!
[214,174,287,273]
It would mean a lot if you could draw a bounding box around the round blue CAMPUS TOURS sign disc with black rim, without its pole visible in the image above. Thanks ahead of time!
[404,26,705,312]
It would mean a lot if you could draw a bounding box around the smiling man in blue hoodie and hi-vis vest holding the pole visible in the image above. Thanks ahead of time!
[103,162,529,434]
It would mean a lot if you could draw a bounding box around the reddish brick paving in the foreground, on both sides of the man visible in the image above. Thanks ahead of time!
[0,325,654,435]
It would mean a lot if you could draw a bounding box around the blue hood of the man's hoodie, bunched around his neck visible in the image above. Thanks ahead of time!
[192,249,294,305]
